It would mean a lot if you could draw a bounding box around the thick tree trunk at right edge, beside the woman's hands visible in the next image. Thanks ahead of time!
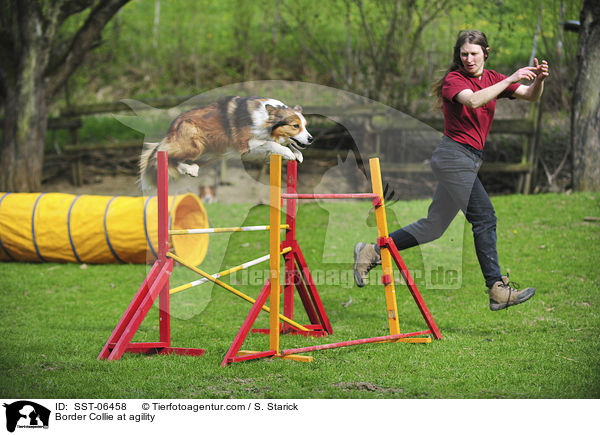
[571,0,600,191]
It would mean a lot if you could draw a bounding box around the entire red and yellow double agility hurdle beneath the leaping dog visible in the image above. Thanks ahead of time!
[98,151,442,366]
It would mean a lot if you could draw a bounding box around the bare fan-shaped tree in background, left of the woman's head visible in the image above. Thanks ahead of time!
[281,0,453,106]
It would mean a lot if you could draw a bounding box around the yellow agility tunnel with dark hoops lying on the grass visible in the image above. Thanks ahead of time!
[0,192,209,265]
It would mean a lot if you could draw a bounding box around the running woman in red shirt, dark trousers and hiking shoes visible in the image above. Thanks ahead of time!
[354,30,549,311]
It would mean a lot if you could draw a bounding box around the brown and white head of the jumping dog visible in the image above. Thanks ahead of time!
[265,104,313,150]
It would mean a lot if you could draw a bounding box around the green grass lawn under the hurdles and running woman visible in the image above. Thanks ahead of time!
[0,193,600,398]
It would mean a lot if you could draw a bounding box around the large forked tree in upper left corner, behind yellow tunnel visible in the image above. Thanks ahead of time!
[0,0,129,192]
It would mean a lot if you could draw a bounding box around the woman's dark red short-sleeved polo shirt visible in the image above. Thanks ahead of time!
[442,69,519,150]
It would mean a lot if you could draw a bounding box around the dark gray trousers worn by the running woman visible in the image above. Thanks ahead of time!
[390,136,502,288]
